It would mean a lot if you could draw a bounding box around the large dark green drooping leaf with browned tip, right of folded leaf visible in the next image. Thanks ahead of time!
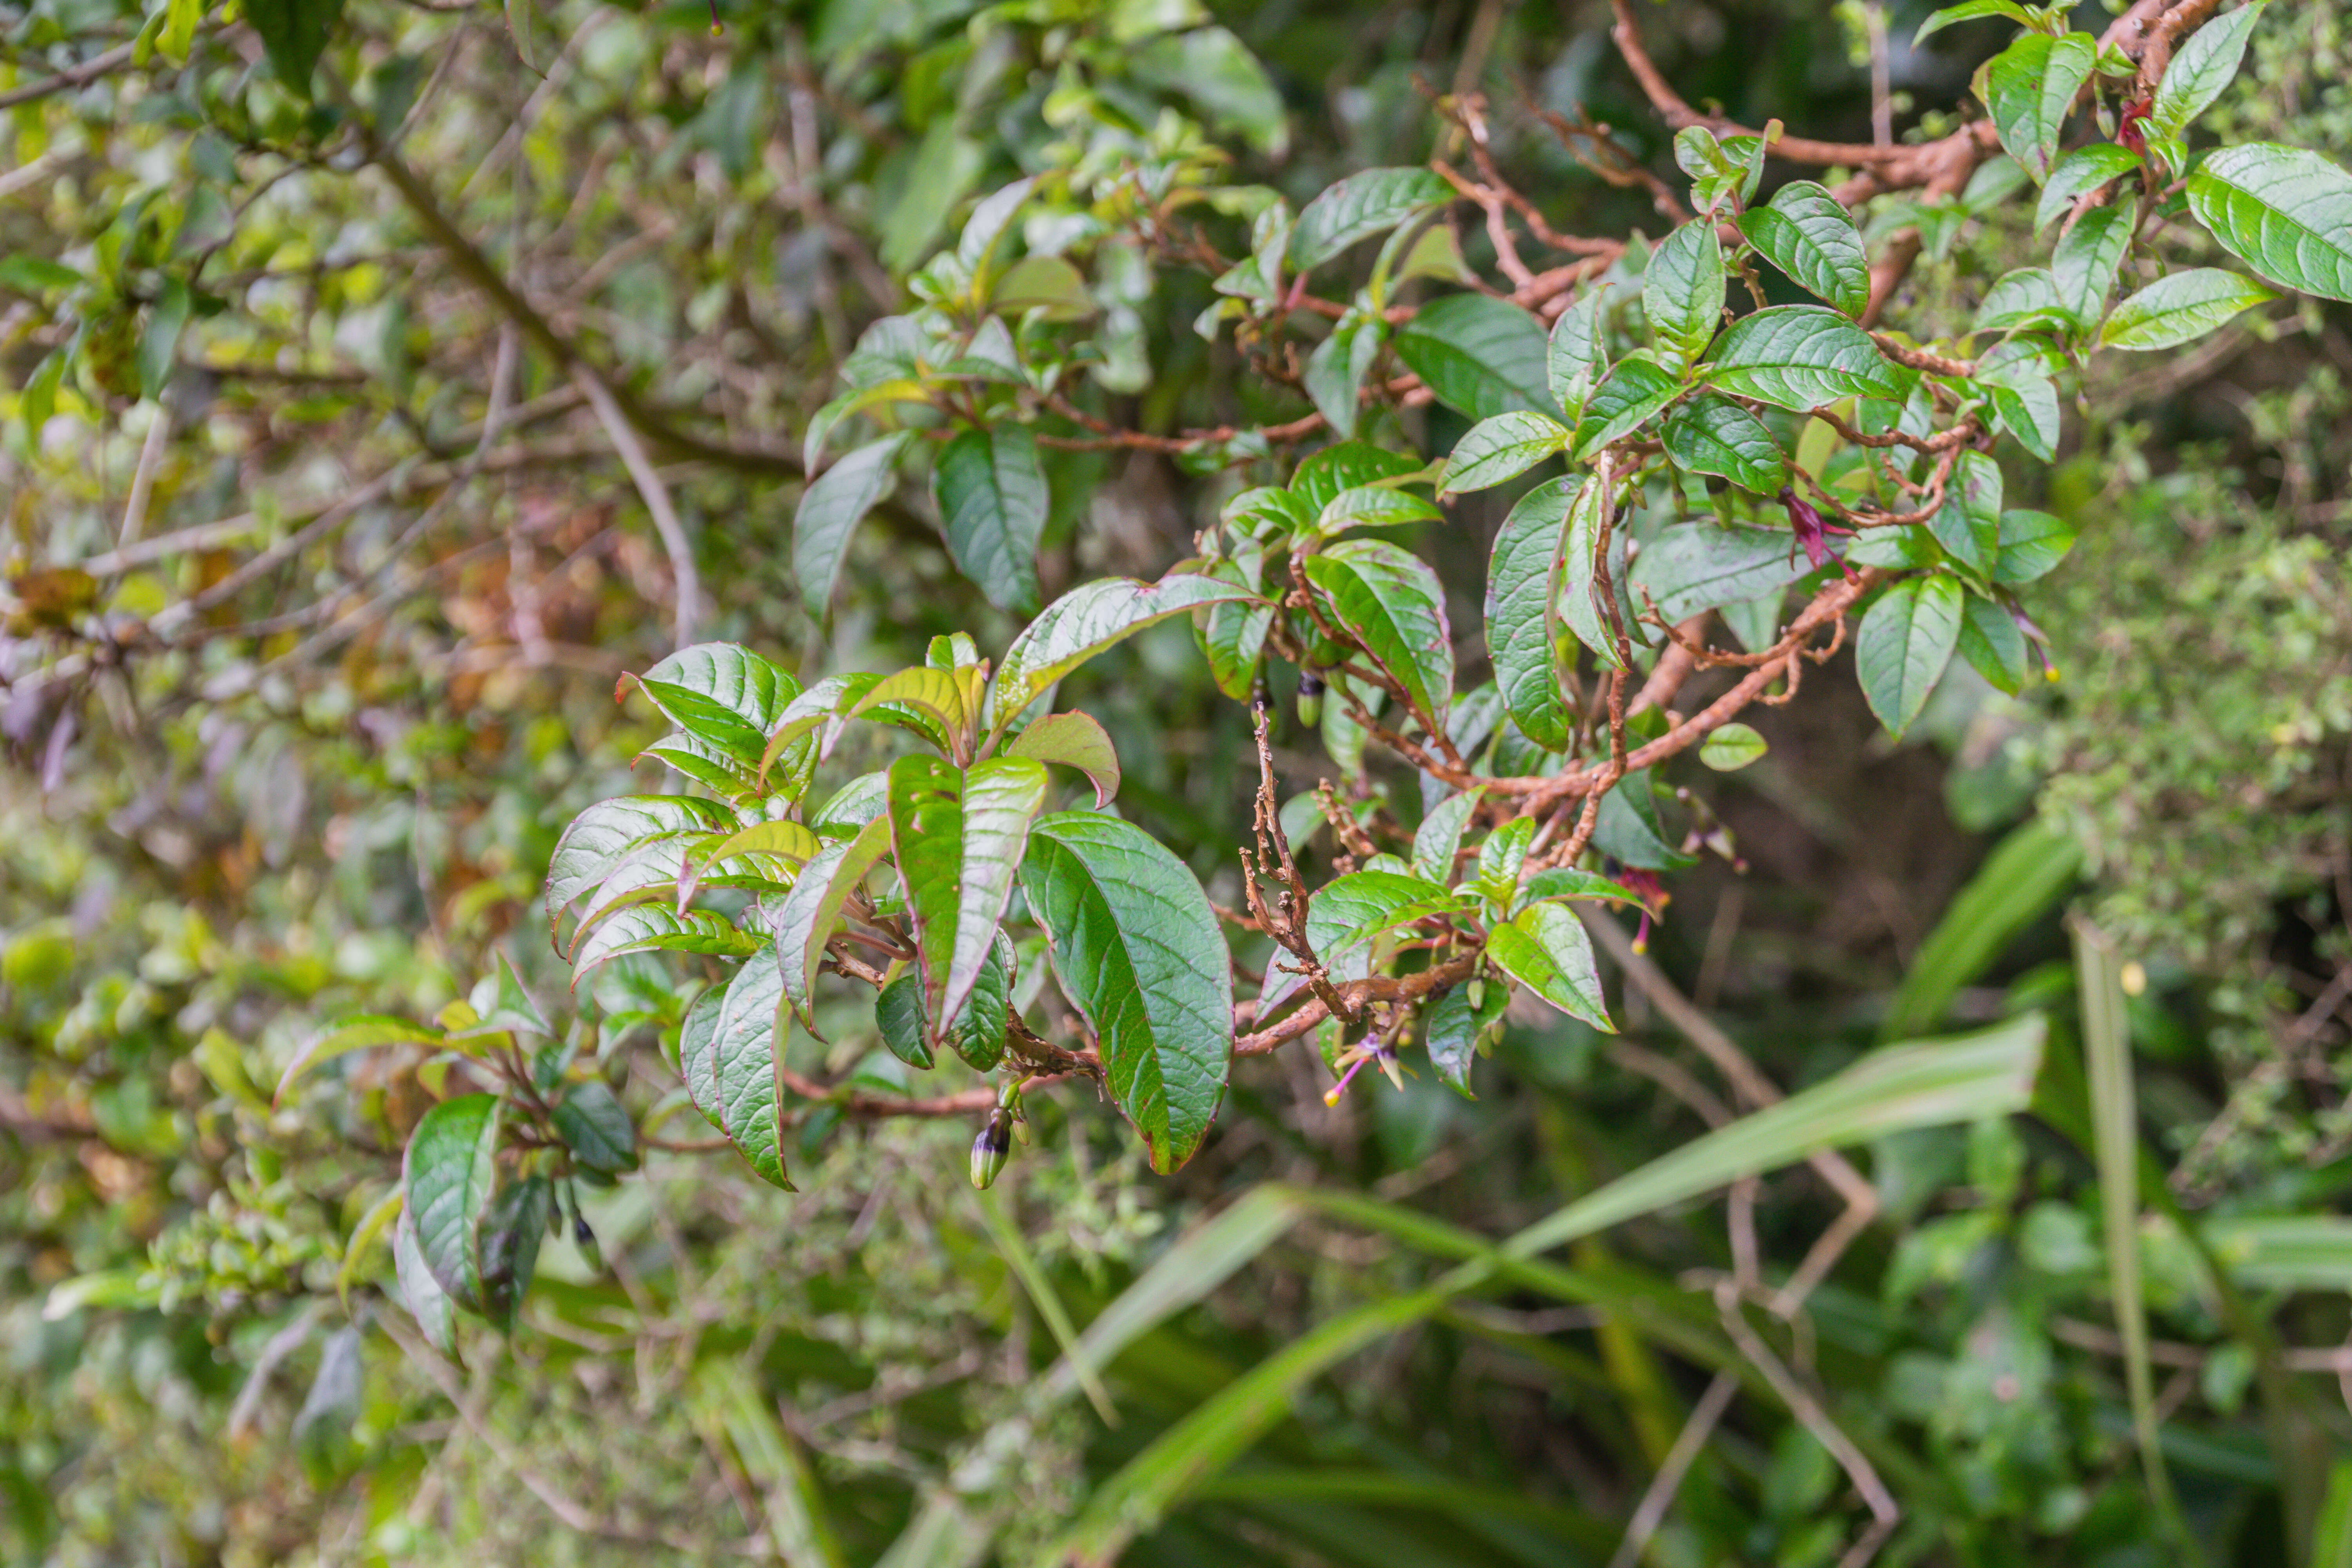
[1021,811,1232,1173]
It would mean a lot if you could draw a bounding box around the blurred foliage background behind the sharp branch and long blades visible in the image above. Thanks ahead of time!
[0,0,2352,1568]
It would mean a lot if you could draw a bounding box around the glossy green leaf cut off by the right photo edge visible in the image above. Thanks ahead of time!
[2190,141,2352,301]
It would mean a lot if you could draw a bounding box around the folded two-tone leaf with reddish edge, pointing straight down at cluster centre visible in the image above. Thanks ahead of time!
[889,755,1047,1020]
